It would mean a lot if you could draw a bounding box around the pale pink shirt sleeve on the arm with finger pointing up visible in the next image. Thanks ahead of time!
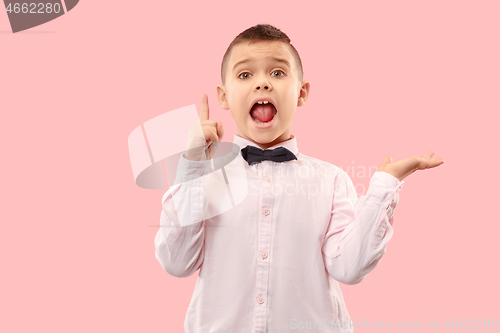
[154,155,209,277]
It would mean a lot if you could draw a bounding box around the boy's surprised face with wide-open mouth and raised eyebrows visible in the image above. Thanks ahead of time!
[217,41,310,149]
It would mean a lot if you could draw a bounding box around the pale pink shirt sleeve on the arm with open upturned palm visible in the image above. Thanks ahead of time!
[322,171,404,284]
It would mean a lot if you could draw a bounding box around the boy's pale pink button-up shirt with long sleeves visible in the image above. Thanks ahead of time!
[155,135,404,333]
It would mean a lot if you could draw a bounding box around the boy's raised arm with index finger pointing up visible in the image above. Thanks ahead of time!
[155,94,224,277]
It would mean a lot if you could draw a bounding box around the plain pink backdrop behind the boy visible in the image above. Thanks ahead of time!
[0,0,500,333]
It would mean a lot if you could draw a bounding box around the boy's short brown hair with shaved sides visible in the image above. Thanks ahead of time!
[221,24,304,84]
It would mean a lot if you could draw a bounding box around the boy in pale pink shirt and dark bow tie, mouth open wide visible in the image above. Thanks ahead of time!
[155,25,444,333]
